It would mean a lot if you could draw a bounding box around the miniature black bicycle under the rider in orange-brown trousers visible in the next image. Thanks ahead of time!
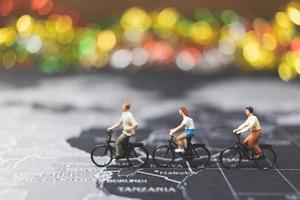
[219,134,277,169]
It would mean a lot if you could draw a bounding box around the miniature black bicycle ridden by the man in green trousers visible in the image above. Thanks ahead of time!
[91,131,149,168]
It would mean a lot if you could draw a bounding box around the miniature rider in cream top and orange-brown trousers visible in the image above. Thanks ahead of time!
[233,106,262,158]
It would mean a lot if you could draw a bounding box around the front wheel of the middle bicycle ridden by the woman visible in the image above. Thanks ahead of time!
[152,145,175,167]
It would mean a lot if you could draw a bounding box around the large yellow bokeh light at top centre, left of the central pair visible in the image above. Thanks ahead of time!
[121,7,151,31]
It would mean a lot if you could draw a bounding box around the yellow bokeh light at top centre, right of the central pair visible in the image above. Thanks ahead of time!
[156,8,179,29]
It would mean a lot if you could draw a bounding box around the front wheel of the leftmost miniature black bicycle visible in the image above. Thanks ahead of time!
[91,145,113,167]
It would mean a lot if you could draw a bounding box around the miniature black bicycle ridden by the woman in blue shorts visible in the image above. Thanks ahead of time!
[152,136,210,169]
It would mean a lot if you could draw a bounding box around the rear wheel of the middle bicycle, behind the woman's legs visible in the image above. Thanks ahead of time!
[188,146,210,169]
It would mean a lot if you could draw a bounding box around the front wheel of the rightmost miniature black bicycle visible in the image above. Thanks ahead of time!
[219,147,241,169]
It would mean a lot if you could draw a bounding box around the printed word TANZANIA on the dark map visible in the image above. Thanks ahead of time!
[118,187,176,193]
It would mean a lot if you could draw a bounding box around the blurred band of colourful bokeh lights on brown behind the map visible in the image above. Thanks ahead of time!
[0,0,300,81]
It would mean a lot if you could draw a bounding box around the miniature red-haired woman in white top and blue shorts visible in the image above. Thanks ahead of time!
[170,107,195,152]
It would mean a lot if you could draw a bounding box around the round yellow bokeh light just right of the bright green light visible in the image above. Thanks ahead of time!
[97,30,117,51]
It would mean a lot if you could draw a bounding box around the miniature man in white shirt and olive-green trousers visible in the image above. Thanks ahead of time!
[107,101,138,160]
